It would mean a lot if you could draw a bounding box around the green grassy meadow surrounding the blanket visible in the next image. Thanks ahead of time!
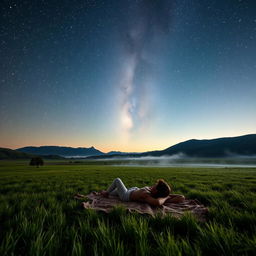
[0,161,256,256]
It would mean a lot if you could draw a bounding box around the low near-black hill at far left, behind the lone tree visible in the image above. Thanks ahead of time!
[0,148,62,160]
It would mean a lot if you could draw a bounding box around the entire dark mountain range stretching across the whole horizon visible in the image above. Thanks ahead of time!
[0,134,256,159]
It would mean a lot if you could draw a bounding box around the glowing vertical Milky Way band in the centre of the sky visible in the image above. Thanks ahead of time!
[120,0,172,138]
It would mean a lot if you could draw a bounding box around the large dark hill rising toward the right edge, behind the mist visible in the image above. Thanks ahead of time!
[87,134,256,158]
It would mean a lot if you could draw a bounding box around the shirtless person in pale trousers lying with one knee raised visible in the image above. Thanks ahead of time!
[100,178,185,206]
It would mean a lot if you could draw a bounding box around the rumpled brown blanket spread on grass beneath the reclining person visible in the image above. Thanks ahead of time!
[75,192,208,221]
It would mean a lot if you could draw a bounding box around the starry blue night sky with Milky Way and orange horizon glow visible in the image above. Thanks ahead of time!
[0,0,256,152]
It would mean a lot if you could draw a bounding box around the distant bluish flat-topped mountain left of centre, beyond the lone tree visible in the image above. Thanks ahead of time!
[17,146,104,157]
